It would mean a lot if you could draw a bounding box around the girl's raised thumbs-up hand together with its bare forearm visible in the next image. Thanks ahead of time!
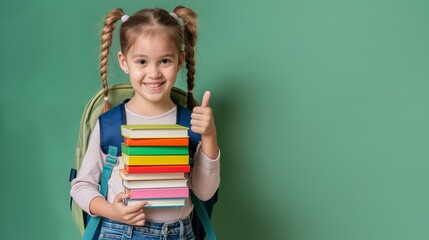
[191,91,218,159]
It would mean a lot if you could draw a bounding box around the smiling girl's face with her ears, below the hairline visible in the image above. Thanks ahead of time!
[118,34,184,107]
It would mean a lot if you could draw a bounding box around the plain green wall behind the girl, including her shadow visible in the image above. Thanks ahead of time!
[0,0,429,240]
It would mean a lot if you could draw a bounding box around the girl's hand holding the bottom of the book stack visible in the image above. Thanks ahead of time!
[110,193,147,226]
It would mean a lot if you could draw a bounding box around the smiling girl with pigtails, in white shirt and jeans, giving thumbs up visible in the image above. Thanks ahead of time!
[71,6,220,239]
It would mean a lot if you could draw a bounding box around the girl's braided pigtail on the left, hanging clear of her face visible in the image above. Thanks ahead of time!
[100,8,124,113]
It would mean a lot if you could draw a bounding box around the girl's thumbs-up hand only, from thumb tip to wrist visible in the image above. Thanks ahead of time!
[191,91,216,136]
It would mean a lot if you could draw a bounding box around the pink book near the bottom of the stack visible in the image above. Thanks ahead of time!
[125,187,189,199]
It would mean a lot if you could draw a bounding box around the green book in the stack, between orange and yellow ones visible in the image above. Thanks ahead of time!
[122,143,189,156]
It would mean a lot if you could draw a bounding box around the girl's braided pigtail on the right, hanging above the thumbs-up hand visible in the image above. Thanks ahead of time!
[174,6,197,110]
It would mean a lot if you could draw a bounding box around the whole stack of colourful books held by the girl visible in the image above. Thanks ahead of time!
[120,124,190,207]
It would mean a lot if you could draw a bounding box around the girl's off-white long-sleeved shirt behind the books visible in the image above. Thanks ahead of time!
[70,105,220,222]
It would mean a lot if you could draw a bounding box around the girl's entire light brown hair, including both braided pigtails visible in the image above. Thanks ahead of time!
[100,6,197,112]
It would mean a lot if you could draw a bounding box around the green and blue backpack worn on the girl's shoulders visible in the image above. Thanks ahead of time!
[69,84,218,240]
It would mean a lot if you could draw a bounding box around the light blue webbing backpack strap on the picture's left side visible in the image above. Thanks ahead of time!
[82,146,118,240]
